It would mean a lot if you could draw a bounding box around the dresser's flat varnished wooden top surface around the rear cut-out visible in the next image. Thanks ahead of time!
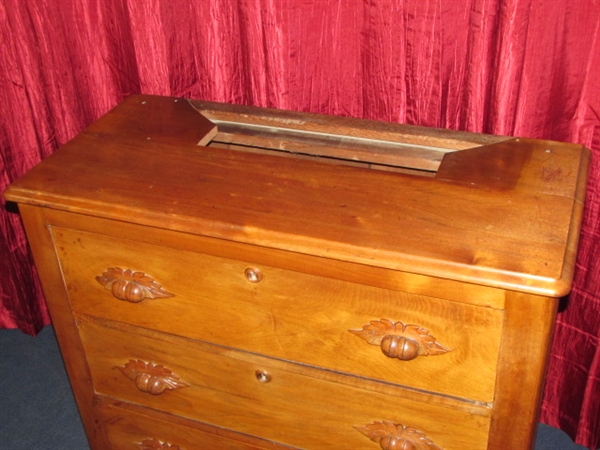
[5,96,589,296]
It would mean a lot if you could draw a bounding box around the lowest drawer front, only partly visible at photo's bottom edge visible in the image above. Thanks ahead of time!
[100,405,290,450]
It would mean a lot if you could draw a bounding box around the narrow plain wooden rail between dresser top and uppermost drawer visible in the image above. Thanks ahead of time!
[34,208,506,309]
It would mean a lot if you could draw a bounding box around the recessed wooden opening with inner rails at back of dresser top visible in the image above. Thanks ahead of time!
[190,100,508,176]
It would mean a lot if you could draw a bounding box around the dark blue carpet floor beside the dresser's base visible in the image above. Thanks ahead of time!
[0,327,585,450]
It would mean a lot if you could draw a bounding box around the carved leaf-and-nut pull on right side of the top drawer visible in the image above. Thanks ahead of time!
[349,319,451,361]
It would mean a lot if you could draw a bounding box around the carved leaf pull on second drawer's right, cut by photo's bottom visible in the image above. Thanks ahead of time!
[354,420,442,450]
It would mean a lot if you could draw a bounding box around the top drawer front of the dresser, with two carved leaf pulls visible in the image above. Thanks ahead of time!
[53,227,502,402]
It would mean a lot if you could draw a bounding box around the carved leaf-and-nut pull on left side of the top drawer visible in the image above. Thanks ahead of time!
[96,267,173,303]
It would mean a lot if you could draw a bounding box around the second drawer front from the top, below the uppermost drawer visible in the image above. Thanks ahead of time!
[80,320,489,450]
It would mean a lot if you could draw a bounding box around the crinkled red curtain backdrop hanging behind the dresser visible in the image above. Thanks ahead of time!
[0,0,600,449]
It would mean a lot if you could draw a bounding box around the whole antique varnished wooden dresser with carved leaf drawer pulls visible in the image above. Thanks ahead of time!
[5,96,589,450]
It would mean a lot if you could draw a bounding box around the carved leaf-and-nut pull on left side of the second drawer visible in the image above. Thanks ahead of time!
[116,359,190,395]
